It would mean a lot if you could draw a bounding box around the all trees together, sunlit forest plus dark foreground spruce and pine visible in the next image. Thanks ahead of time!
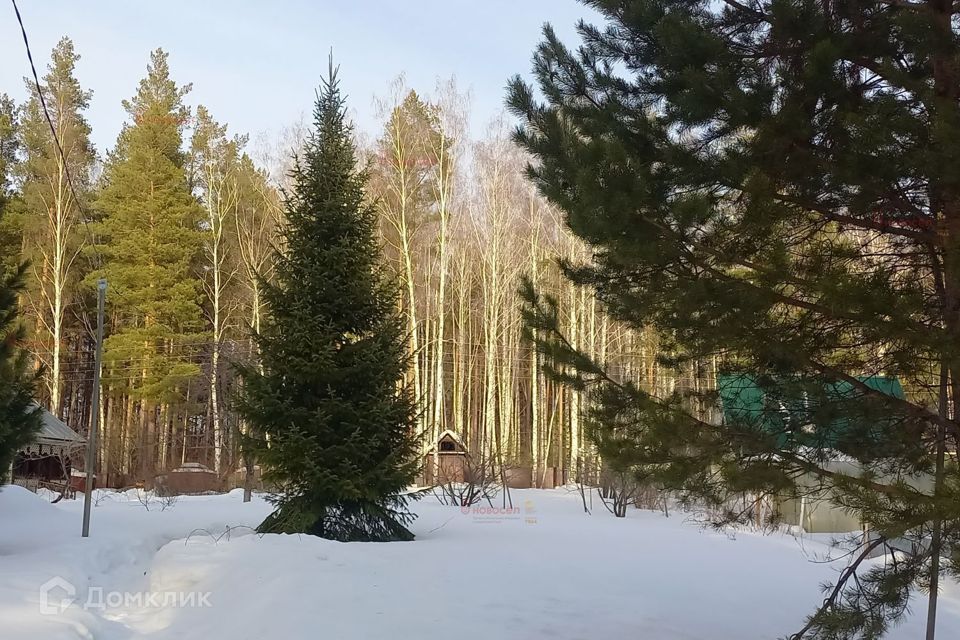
[0,0,960,639]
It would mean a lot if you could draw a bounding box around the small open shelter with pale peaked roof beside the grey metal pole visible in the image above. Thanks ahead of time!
[12,405,86,497]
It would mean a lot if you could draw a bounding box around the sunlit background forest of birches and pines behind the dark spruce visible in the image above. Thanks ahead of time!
[0,38,688,486]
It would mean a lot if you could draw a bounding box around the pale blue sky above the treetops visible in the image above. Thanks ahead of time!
[0,0,593,153]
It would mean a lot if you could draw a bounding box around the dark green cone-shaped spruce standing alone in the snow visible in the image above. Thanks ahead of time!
[238,63,417,541]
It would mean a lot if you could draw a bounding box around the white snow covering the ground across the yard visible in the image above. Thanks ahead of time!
[0,487,960,640]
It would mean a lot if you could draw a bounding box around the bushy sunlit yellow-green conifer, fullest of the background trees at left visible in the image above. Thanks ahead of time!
[97,49,204,476]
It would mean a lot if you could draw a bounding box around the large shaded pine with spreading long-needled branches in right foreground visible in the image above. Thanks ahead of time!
[509,0,960,638]
